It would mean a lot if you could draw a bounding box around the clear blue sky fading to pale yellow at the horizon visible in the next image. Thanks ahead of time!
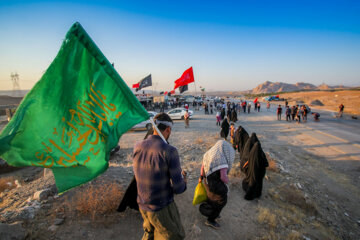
[0,0,360,91]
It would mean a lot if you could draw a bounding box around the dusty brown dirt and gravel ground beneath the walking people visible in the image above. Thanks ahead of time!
[0,102,360,240]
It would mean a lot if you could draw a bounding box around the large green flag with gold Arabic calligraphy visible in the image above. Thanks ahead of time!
[0,23,149,192]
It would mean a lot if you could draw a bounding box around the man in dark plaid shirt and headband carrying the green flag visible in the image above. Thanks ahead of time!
[133,113,187,240]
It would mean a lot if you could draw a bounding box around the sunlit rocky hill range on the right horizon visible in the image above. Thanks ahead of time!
[250,81,347,94]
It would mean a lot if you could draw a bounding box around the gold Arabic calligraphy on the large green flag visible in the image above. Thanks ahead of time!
[32,84,122,168]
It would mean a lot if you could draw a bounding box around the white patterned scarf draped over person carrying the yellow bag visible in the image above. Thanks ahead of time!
[203,140,235,177]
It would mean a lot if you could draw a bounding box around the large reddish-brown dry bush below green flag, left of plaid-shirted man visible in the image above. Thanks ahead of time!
[65,181,123,220]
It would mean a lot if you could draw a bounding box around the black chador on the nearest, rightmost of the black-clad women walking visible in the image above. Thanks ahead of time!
[242,142,269,200]
